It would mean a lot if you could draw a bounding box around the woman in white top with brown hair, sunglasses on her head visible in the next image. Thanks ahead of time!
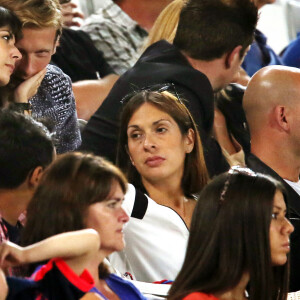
[110,84,208,282]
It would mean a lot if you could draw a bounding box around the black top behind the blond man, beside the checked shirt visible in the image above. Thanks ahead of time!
[51,28,114,82]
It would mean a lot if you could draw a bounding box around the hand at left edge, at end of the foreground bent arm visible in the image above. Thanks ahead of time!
[0,241,25,269]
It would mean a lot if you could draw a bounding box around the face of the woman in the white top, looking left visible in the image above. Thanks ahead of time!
[127,103,194,182]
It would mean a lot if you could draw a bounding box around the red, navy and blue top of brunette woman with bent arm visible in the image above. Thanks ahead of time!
[7,258,146,300]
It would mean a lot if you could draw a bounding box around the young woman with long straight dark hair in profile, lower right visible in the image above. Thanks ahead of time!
[169,167,294,300]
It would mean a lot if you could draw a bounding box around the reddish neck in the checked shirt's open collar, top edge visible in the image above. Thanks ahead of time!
[116,0,171,31]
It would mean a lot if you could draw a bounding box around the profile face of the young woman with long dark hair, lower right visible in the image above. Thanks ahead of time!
[270,190,294,266]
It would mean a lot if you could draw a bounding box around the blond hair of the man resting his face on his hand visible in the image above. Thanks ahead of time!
[0,0,62,35]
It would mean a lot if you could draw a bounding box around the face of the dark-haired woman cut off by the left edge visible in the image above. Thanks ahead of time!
[0,26,22,86]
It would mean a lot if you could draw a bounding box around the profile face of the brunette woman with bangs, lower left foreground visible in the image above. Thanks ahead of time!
[86,182,129,255]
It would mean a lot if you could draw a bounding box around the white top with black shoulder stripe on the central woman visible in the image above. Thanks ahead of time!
[109,184,189,282]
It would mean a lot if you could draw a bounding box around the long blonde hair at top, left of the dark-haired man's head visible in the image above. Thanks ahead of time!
[142,0,187,51]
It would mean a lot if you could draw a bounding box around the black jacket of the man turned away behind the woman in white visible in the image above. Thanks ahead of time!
[80,41,228,175]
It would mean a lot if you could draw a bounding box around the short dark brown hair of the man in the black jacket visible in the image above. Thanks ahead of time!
[173,0,258,61]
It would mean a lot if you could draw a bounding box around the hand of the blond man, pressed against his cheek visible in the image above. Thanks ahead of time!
[14,68,46,103]
